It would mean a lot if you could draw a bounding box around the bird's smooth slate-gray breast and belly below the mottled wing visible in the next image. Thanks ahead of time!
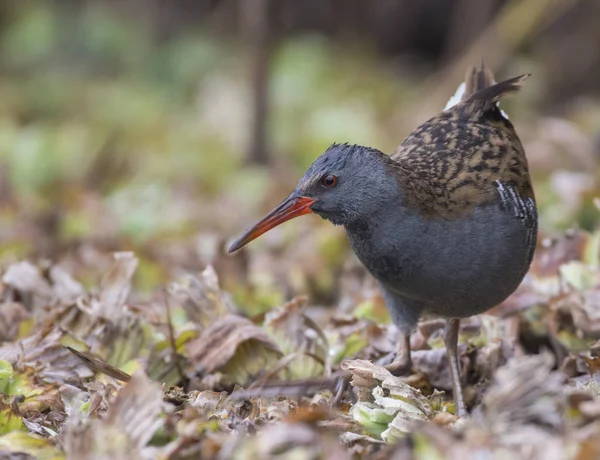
[348,186,537,317]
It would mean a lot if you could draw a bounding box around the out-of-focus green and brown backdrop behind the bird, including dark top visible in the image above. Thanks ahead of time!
[0,0,600,313]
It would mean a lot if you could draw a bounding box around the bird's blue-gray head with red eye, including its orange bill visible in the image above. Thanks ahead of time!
[229,144,398,252]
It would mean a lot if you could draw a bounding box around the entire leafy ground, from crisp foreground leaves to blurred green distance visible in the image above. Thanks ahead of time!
[0,2,600,460]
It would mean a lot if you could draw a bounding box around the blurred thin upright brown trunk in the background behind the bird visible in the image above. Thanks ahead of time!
[240,0,272,164]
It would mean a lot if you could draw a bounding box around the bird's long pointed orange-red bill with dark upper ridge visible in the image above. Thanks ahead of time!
[228,194,315,253]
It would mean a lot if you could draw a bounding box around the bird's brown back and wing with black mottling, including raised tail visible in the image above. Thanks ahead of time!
[391,70,533,219]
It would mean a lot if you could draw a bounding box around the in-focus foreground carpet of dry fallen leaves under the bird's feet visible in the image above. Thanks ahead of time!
[0,223,600,459]
